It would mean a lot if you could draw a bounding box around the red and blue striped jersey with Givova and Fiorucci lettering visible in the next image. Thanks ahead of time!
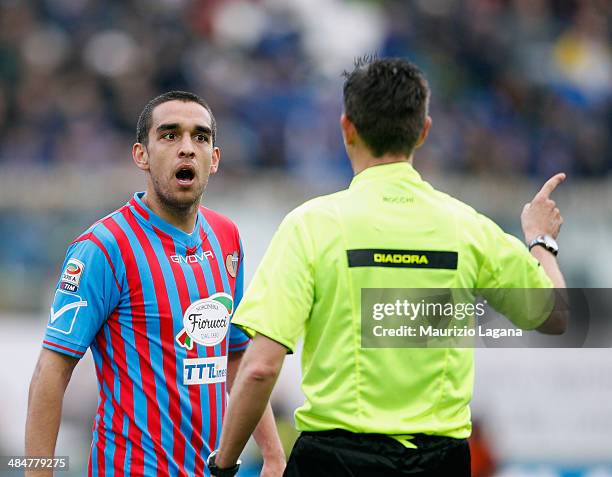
[43,193,249,476]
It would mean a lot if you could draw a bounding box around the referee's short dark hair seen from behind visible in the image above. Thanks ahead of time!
[344,57,429,157]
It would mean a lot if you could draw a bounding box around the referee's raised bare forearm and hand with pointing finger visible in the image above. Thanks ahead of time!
[521,173,568,334]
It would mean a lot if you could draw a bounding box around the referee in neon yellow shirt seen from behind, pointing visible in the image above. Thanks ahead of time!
[209,59,566,477]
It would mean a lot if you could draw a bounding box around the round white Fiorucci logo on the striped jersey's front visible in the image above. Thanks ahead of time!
[176,293,234,349]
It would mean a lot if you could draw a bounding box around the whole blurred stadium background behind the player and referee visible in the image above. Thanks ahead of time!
[0,0,612,477]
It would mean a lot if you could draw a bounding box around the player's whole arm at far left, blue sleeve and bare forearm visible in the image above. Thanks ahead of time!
[25,234,119,475]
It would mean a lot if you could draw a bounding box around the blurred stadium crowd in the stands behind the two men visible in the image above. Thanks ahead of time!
[0,0,612,181]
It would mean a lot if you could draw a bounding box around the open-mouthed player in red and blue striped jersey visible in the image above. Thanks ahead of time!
[26,91,285,477]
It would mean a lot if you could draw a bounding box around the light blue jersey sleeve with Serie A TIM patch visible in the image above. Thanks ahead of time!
[43,239,120,358]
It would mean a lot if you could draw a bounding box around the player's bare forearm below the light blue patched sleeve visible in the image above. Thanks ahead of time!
[25,349,79,476]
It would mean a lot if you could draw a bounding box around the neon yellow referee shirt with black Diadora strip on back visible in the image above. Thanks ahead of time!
[233,162,552,445]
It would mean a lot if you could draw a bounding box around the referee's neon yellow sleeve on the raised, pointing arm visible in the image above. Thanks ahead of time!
[477,216,555,330]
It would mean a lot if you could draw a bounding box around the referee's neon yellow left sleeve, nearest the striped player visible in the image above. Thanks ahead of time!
[234,212,314,352]
